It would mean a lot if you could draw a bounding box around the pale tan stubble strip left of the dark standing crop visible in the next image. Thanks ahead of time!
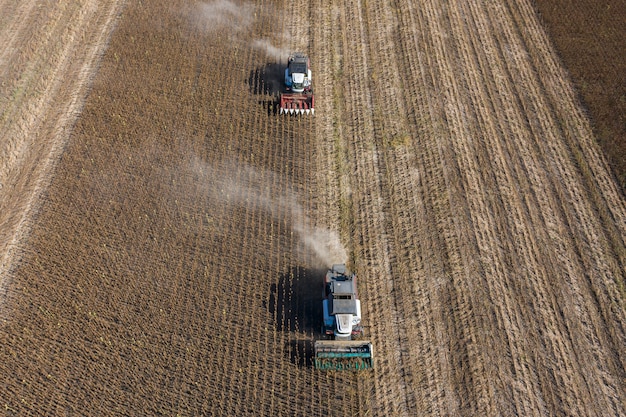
[0,1,127,288]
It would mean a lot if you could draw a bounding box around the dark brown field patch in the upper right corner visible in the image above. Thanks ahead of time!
[535,0,626,192]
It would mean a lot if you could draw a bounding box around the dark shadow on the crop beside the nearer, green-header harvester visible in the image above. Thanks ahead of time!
[266,267,326,367]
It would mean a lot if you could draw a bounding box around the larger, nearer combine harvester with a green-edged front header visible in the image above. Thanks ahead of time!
[315,264,374,370]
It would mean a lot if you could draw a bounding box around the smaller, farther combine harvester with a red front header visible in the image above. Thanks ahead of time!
[280,52,315,114]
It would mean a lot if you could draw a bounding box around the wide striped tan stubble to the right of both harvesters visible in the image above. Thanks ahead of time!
[314,2,624,415]
